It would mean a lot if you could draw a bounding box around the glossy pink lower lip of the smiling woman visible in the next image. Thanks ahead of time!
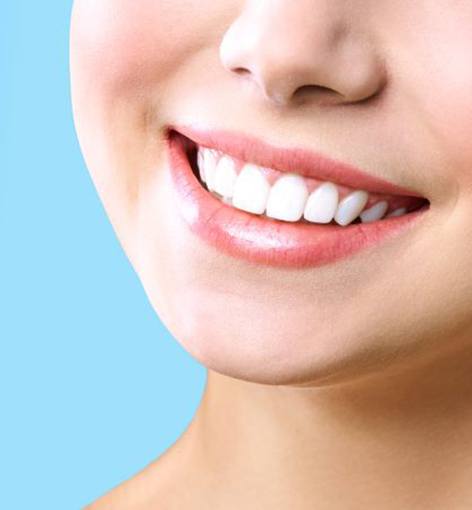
[168,132,426,268]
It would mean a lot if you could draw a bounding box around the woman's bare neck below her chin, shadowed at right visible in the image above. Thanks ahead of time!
[176,342,472,510]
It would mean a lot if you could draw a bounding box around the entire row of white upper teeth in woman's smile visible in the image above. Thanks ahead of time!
[197,147,406,226]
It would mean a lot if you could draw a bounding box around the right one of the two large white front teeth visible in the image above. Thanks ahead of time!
[266,174,308,221]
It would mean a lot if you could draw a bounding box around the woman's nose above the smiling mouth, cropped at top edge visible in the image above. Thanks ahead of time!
[220,0,386,105]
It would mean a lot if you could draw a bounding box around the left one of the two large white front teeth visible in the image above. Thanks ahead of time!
[232,163,270,214]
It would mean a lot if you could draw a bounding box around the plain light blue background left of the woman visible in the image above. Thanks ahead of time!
[0,0,206,510]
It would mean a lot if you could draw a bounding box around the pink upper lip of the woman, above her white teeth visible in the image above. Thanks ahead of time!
[170,125,422,197]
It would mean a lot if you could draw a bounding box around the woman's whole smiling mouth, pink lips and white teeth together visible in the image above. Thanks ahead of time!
[166,126,429,268]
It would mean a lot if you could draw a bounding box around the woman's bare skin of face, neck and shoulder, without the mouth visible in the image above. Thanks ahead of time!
[71,0,472,510]
